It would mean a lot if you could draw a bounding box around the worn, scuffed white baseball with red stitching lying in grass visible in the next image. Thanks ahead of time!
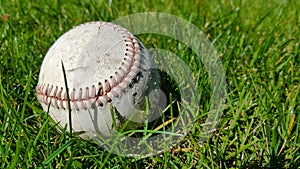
[36,22,159,139]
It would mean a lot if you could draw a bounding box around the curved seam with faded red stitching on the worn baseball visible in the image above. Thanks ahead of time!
[36,22,143,110]
